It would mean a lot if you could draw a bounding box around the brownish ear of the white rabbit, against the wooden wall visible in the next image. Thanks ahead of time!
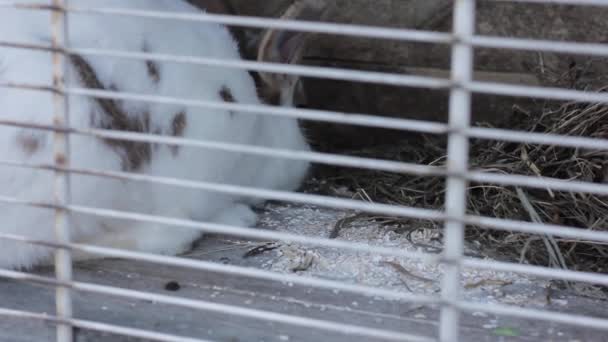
[258,0,328,105]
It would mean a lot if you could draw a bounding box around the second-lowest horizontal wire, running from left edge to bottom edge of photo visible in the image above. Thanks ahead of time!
[0,269,435,342]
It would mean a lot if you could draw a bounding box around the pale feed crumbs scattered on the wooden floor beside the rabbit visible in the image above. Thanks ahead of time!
[260,204,549,304]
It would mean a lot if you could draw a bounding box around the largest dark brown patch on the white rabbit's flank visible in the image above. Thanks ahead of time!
[70,55,152,171]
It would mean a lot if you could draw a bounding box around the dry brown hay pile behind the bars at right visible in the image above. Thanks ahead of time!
[308,96,608,273]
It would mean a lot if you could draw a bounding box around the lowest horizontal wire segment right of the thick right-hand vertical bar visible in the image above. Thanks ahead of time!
[455,302,608,330]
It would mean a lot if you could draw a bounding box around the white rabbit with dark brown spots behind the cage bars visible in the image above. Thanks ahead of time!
[0,0,322,268]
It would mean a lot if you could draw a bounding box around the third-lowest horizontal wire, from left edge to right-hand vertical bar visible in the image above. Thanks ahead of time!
[0,233,439,304]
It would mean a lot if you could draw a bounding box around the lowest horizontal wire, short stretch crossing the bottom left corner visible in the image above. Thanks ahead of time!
[0,308,212,342]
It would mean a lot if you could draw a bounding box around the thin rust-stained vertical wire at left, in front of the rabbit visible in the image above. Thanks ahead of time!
[51,0,73,342]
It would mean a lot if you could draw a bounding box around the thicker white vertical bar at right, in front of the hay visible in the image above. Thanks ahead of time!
[439,0,475,342]
